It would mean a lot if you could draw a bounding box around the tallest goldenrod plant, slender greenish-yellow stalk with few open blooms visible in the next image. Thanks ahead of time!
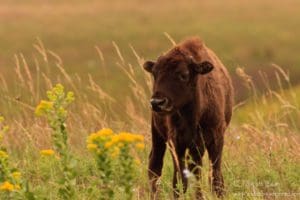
[35,84,76,199]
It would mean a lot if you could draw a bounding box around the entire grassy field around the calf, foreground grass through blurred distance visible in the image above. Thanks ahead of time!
[0,0,300,199]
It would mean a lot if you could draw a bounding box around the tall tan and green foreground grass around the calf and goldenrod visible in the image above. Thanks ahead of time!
[0,40,300,199]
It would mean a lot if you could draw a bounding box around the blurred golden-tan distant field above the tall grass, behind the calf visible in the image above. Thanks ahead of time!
[0,0,300,101]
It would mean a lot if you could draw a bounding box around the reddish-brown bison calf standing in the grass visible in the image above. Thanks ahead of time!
[144,38,233,199]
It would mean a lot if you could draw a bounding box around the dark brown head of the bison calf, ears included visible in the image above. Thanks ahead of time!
[143,50,213,114]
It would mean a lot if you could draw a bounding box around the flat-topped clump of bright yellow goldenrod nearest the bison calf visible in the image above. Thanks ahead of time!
[87,129,144,200]
